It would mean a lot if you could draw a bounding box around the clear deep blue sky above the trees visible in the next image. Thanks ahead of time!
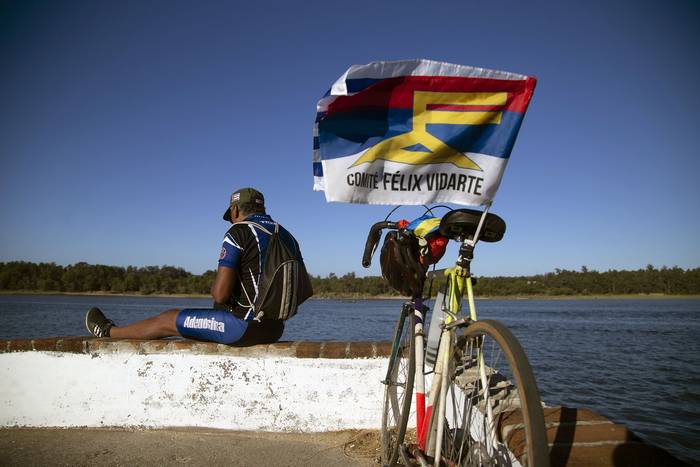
[0,0,700,275]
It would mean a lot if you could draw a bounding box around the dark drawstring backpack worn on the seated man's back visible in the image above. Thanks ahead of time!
[237,221,313,321]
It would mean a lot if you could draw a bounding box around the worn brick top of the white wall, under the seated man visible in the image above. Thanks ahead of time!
[0,337,391,359]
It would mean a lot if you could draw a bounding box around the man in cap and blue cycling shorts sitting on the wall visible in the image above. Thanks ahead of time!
[85,188,306,345]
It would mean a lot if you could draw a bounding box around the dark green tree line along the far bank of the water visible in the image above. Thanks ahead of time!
[0,261,700,297]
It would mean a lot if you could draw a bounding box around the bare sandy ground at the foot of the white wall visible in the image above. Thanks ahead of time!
[0,428,379,467]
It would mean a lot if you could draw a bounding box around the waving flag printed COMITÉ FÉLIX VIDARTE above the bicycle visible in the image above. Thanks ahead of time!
[313,60,536,206]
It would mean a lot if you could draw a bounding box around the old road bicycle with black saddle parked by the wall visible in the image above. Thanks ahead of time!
[362,208,549,467]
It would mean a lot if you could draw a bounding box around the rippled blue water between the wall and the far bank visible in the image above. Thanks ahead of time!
[0,296,700,463]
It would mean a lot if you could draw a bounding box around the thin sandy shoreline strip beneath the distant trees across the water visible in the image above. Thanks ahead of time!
[0,290,700,301]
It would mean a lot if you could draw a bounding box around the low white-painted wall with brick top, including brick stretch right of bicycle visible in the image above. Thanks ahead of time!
[0,338,683,467]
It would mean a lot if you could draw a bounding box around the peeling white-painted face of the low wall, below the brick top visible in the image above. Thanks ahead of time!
[0,352,387,432]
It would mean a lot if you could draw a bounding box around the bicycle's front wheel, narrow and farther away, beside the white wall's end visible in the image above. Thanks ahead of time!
[381,306,416,466]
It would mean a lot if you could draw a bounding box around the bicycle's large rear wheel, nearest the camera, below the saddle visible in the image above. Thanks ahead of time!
[442,320,549,467]
